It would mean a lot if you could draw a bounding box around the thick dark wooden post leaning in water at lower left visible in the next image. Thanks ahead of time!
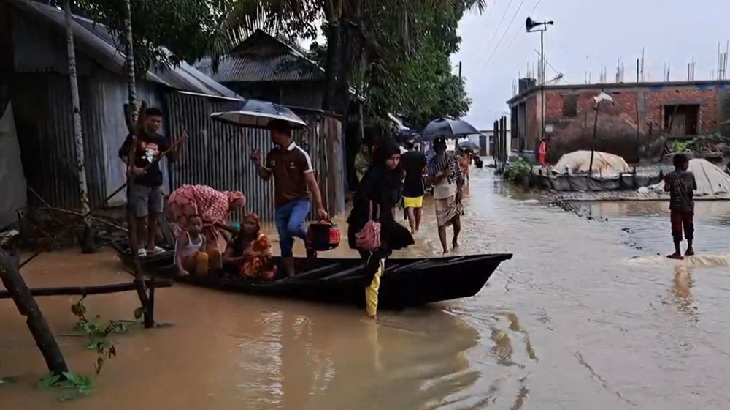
[0,249,69,374]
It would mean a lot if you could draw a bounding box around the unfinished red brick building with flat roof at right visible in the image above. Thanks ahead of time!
[507,79,730,150]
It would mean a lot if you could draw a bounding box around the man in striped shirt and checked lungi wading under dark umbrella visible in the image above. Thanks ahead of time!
[427,136,465,254]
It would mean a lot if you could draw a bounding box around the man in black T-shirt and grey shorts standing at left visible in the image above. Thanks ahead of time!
[118,107,186,256]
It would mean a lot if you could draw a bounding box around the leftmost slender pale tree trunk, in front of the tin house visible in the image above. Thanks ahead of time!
[64,0,89,218]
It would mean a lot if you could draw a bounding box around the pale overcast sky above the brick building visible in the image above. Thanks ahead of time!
[452,0,730,129]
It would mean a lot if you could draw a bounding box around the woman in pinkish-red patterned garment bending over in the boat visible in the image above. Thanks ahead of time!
[168,185,245,258]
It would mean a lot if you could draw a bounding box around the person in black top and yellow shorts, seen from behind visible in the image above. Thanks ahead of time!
[400,139,427,234]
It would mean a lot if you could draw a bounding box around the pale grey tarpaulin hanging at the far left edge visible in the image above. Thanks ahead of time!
[0,102,26,228]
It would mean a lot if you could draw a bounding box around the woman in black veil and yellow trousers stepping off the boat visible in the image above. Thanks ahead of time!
[347,140,414,318]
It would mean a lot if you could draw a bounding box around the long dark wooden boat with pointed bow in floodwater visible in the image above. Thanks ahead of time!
[111,241,512,309]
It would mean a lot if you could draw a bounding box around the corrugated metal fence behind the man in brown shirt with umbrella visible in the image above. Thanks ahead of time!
[167,93,345,221]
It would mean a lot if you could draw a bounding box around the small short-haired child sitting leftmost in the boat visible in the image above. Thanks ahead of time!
[174,214,210,276]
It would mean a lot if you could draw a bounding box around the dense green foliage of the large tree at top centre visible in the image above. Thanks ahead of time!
[228,0,485,125]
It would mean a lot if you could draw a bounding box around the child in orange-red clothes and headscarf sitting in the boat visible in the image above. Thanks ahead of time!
[225,214,276,279]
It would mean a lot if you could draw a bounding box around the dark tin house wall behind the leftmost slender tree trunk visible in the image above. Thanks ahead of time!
[11,72,166,210]
